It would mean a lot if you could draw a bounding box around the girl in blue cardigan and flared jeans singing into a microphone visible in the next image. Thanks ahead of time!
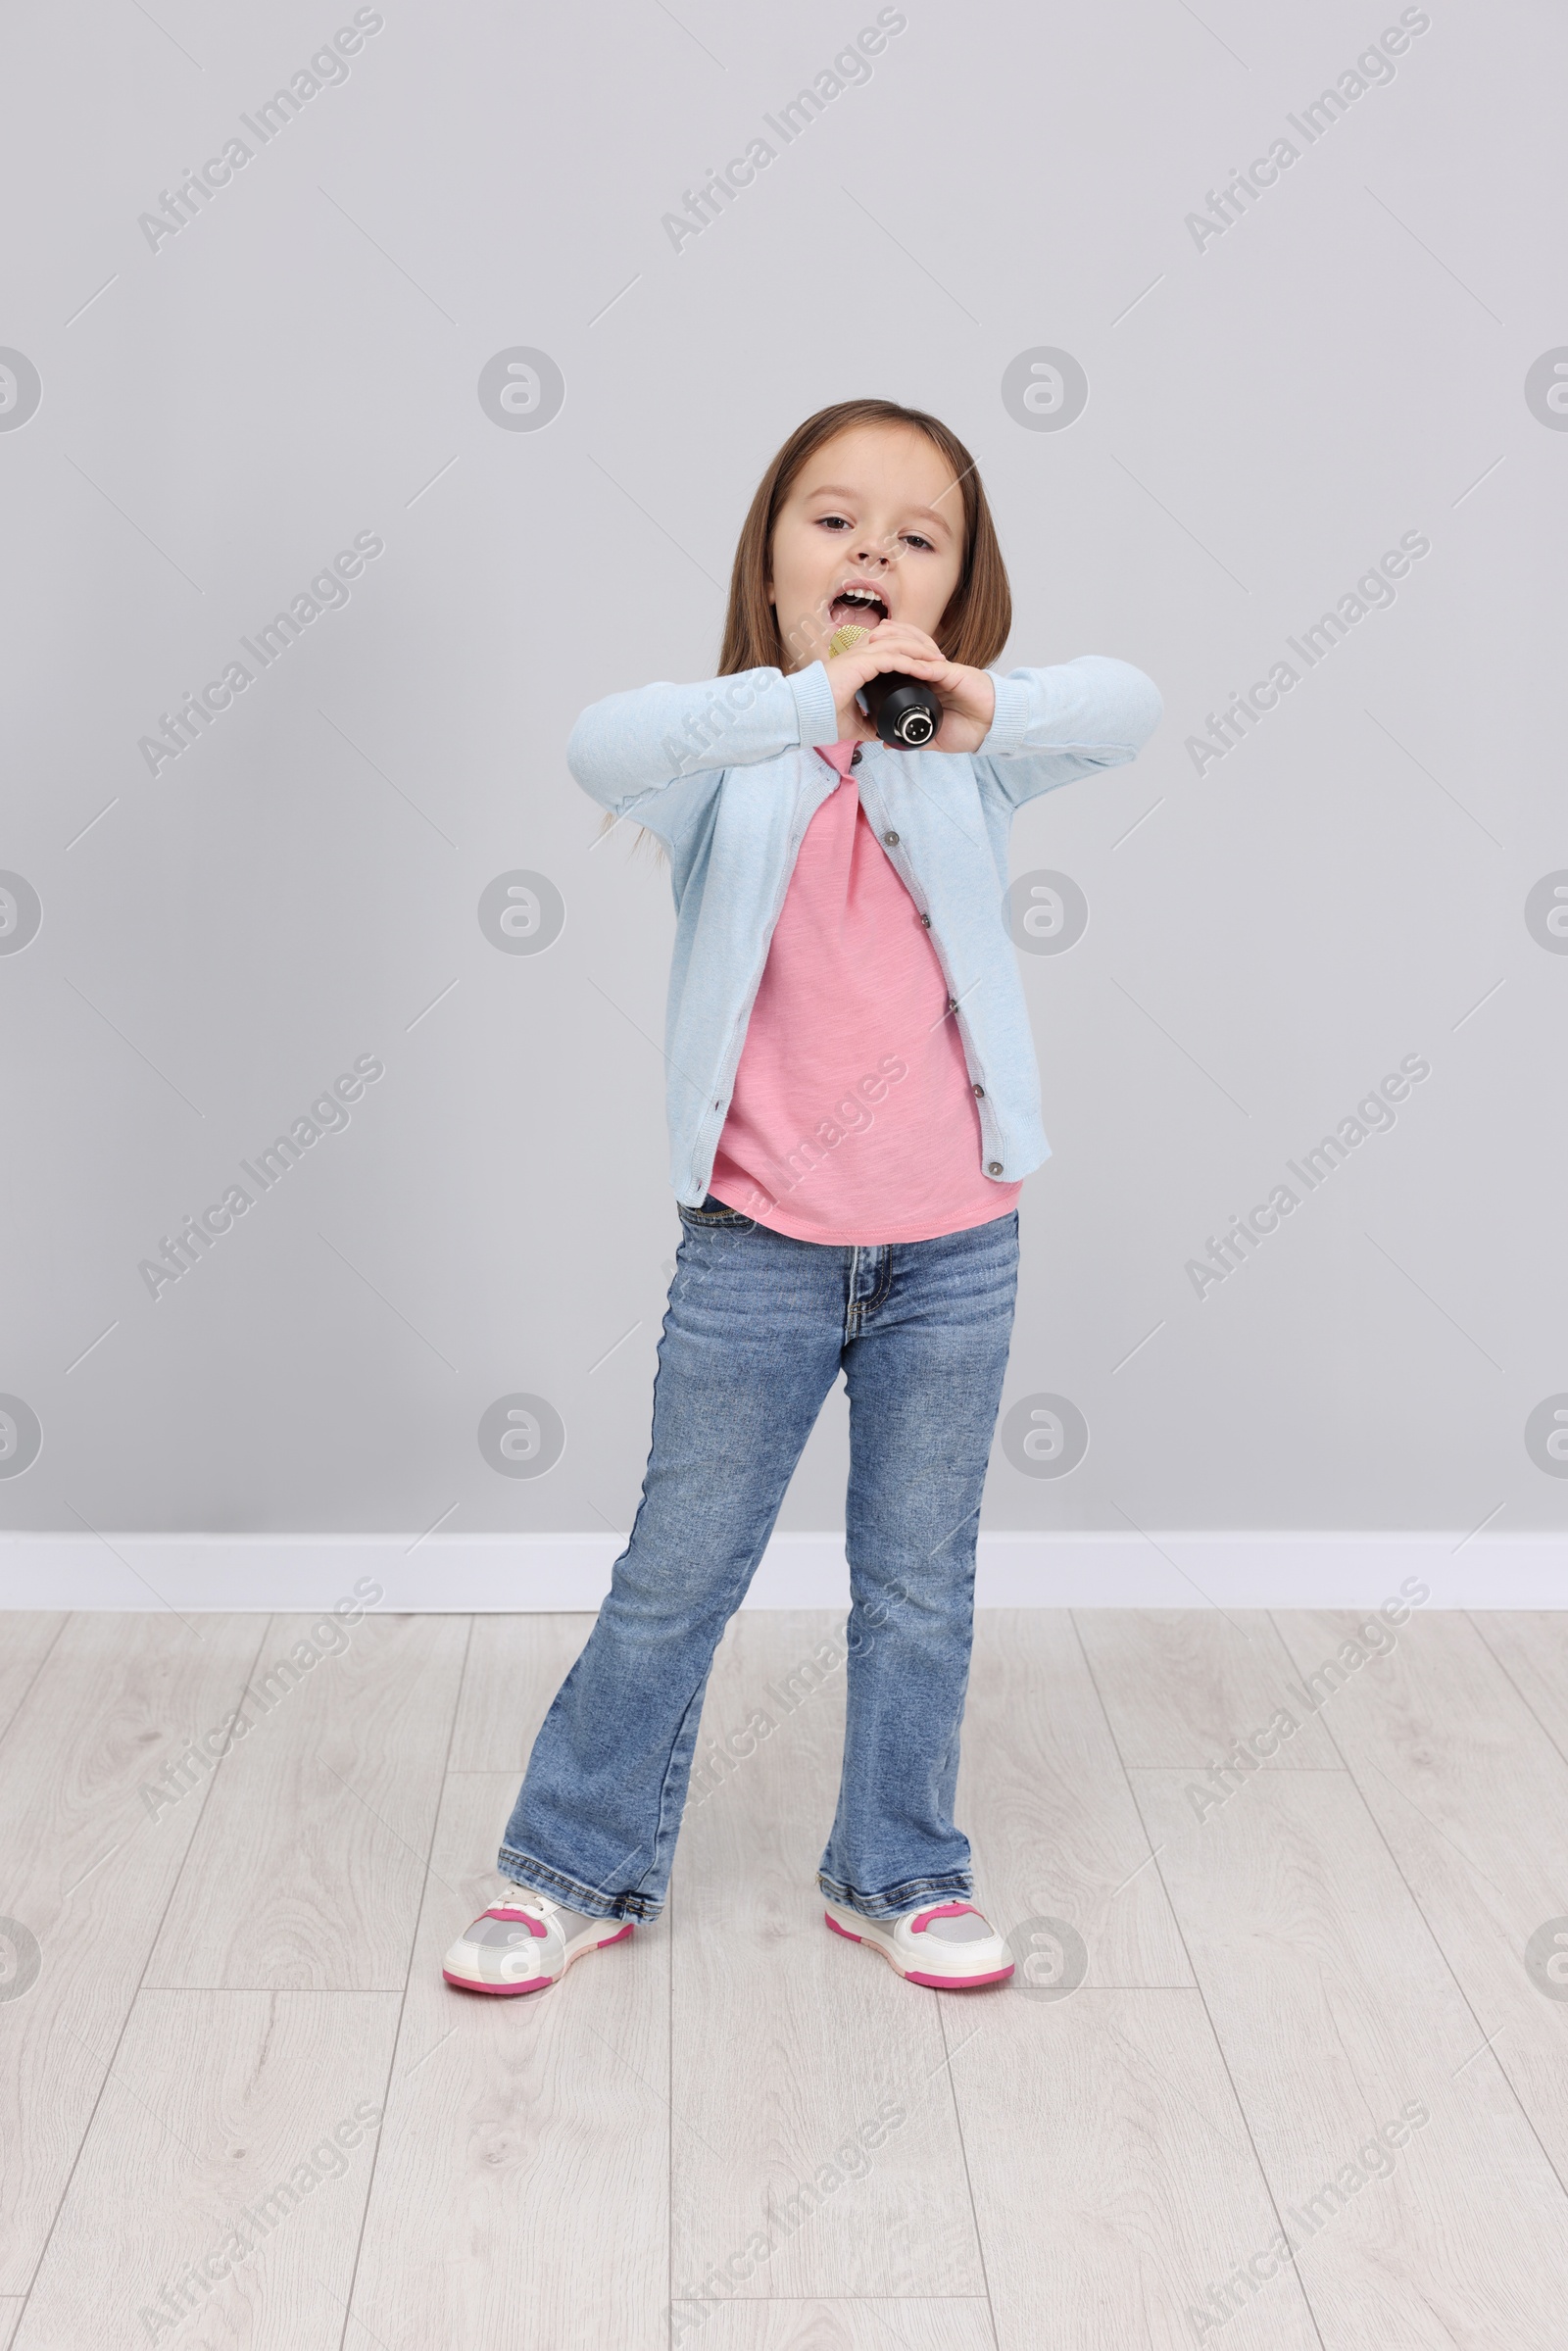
[442,400,1161,1993]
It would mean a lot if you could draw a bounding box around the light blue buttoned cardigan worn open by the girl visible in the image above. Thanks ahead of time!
[566,654,1161,1208]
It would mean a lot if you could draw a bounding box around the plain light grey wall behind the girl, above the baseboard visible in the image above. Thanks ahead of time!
[0,0,1568,1533]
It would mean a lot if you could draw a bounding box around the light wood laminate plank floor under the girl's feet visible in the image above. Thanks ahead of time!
[0,1608,1568,2351]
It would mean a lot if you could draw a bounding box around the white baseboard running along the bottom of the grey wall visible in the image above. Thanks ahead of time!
[0,1533,1568,1615]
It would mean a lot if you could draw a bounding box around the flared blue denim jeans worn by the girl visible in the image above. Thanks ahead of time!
[499,1195,1018,1919]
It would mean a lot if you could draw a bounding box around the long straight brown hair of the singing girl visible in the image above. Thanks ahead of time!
[600,400,1013,860]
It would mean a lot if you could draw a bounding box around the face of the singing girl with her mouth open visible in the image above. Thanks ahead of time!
[766,425,964,670]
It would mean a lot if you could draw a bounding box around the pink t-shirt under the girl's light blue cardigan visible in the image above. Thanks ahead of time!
[708,743,1022,1246]
